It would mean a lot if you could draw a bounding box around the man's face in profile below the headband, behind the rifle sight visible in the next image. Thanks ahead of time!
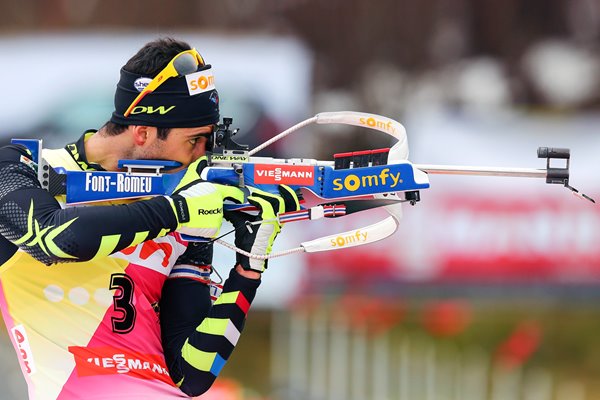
[136,125,213,172]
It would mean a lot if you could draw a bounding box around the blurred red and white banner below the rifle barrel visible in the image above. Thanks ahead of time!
[306,192,600,283]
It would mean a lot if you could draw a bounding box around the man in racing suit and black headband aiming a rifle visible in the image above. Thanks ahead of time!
[0,39,299,399]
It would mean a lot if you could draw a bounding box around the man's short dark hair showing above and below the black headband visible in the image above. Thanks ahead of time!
[103,37,192,140]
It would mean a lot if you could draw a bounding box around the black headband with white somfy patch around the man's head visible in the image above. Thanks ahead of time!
[110,65,219,128]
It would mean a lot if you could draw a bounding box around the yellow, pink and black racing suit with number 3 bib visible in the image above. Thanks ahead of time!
[0,131,260,400]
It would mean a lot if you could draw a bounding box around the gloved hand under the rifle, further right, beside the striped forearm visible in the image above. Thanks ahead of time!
[225,185,300,272]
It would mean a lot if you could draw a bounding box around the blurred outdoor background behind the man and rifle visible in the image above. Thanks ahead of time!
[0,0,600,400]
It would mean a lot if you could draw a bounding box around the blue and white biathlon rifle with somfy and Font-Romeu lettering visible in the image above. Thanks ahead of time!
[13,111,595,259]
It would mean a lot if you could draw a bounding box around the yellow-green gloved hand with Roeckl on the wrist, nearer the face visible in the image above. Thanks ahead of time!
[168,157,244,238]
